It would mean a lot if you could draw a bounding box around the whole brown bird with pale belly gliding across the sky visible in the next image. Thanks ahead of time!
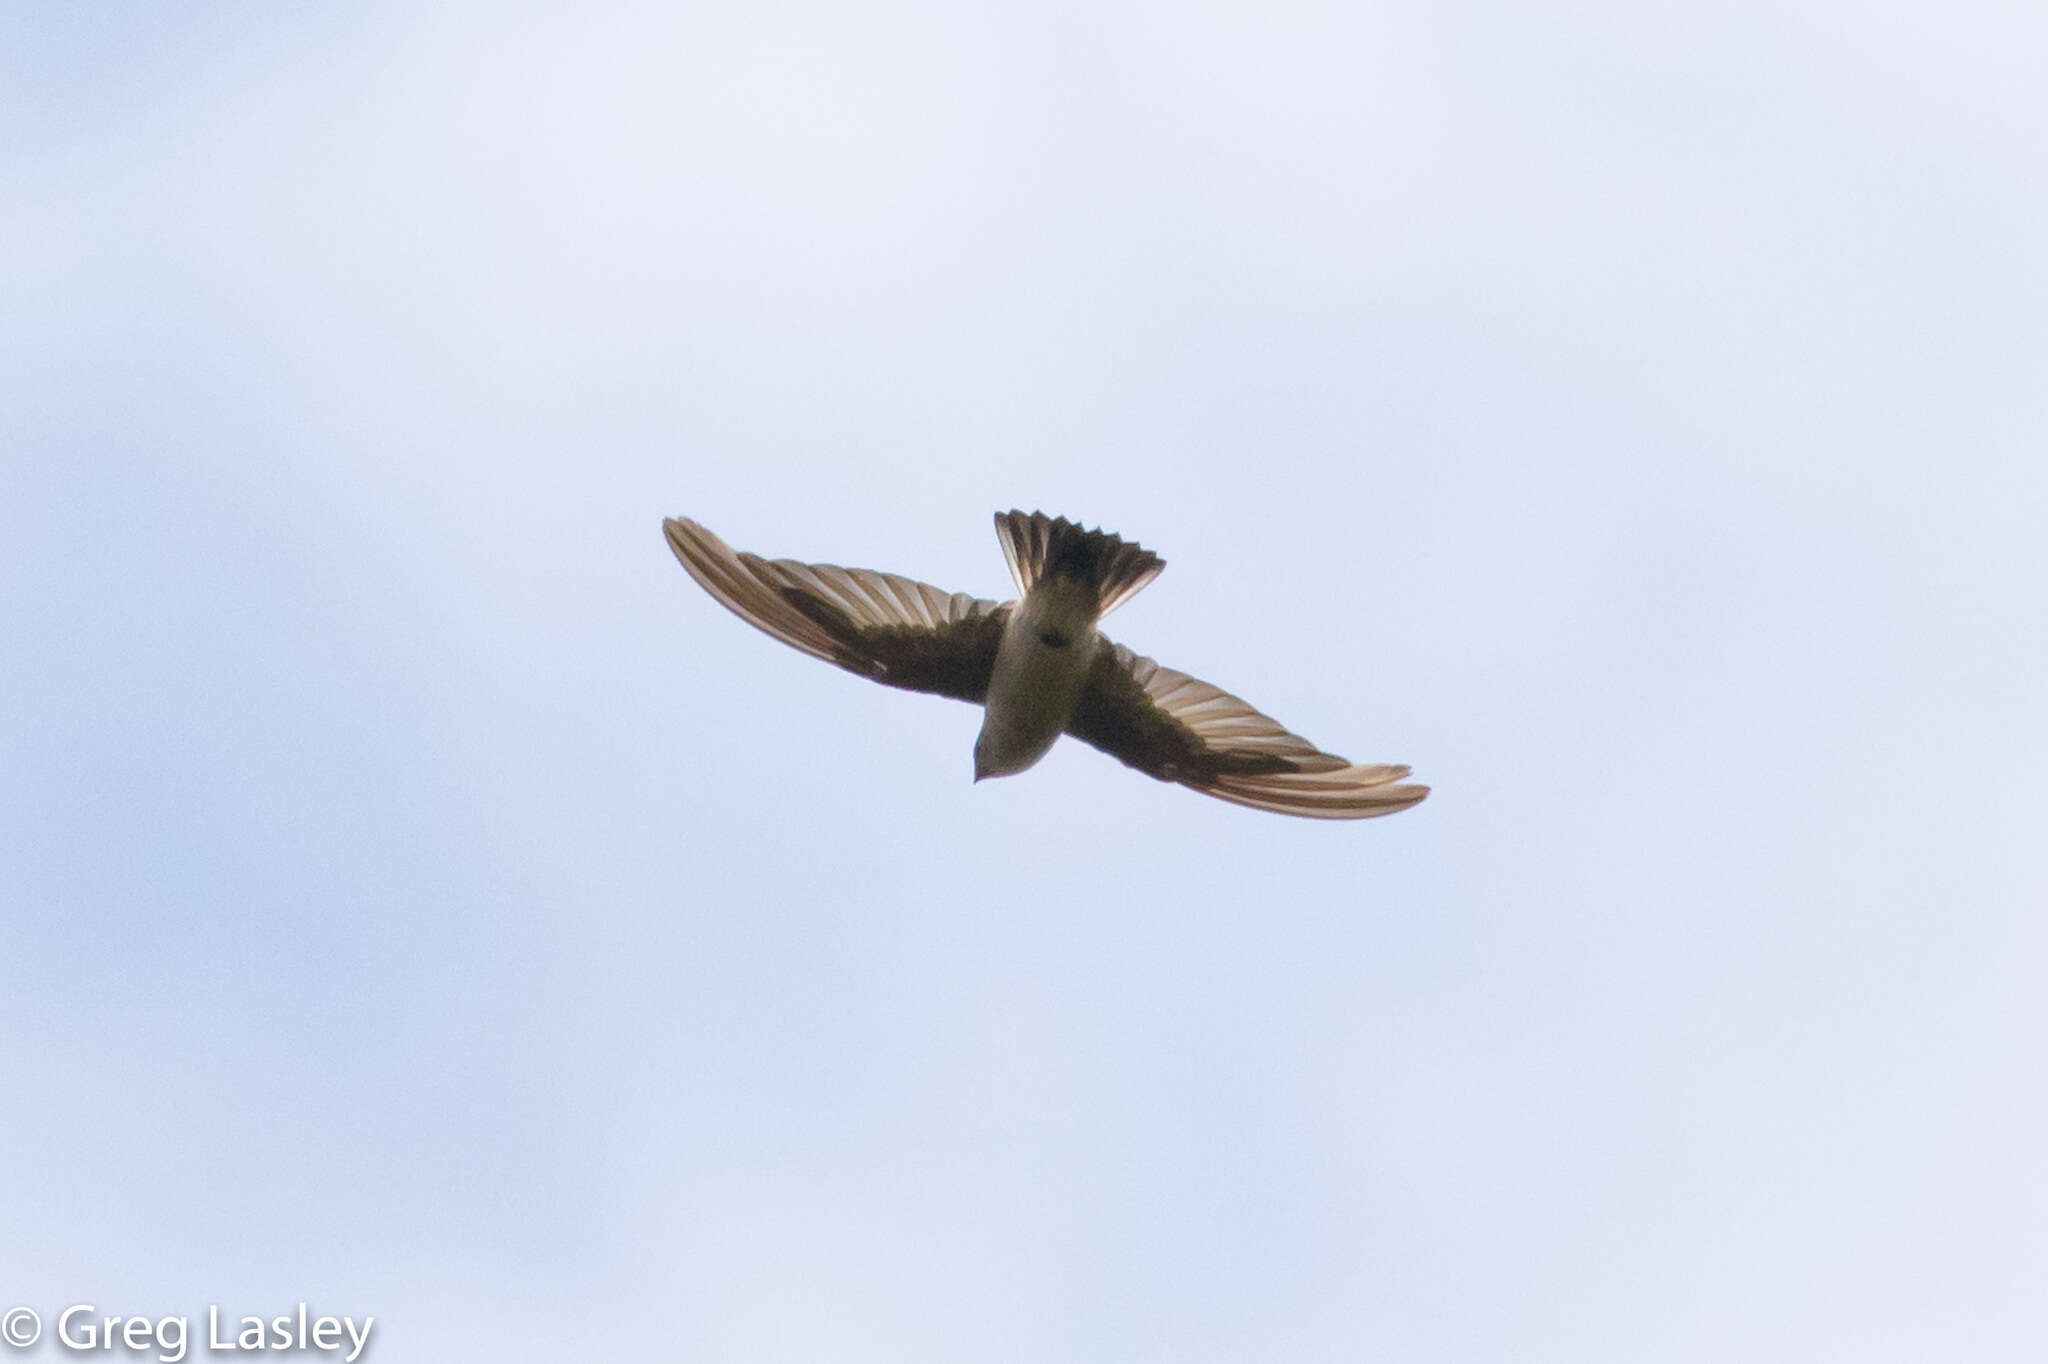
[662,512,1430,806]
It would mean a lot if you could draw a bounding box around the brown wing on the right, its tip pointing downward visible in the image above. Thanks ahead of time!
[1067,639,1430,819]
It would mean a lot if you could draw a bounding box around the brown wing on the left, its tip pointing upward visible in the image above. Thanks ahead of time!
[662,518,1010,700]
